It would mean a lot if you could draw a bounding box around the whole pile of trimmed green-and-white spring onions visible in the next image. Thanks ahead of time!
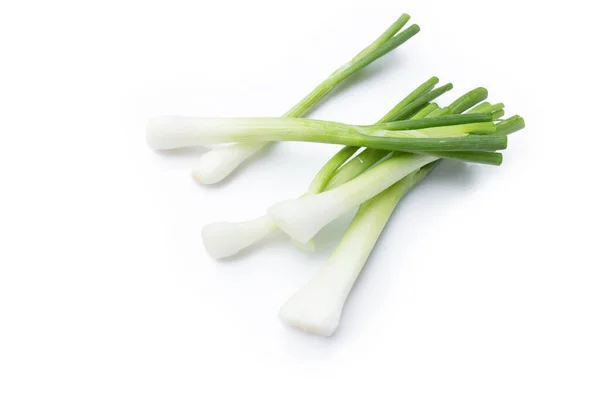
[147,15,525,336]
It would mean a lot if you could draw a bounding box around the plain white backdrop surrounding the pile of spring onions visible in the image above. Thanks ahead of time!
[0,0,600,400]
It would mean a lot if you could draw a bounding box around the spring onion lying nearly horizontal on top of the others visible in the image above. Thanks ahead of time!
[147,114,507,162]
